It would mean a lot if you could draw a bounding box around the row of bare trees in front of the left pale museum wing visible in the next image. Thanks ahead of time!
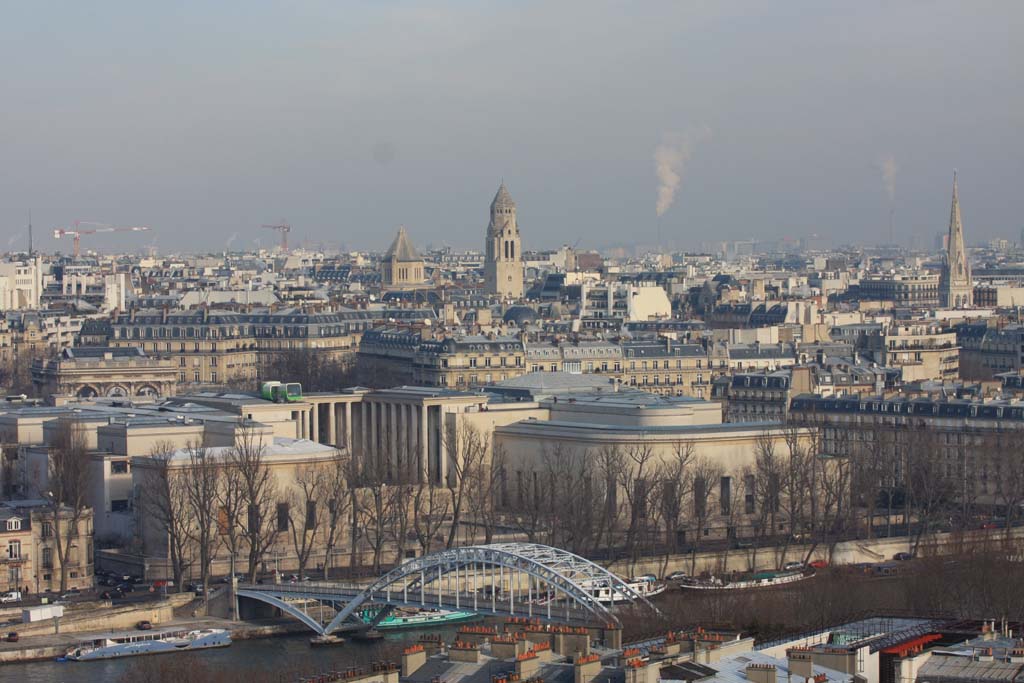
[139,426,351,610]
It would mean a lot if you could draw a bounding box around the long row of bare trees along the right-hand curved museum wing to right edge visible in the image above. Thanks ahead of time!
[494,424,1024,570]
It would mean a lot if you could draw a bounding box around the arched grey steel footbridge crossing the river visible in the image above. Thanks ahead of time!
[238,543,657,635]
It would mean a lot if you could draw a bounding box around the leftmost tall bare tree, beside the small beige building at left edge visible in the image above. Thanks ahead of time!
[37,419,90,592]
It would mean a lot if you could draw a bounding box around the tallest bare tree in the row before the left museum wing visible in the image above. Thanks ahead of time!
[227,424,280,583]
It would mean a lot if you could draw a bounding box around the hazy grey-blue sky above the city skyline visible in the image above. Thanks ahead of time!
[0,0,1024,250]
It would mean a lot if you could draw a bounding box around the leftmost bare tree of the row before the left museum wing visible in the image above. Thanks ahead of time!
[142,441,193,591]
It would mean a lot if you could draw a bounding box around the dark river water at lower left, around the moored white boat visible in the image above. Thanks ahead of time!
[0,628,455,683]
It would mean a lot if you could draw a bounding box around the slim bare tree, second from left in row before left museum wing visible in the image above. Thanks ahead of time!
[182,443,222,605]
